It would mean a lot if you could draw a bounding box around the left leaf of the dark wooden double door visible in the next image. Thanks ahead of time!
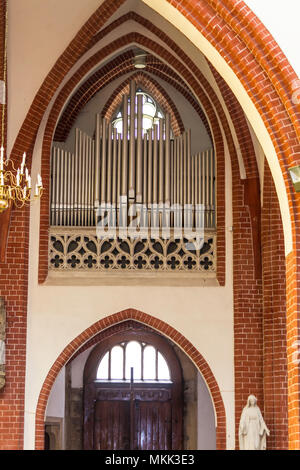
[94,400,130,450]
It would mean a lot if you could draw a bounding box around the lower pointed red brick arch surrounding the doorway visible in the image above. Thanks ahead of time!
[35,309,226,450]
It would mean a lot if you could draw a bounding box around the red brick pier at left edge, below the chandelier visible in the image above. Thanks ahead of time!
[0,209,29,450]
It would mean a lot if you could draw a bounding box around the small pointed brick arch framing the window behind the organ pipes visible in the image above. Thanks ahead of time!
[102,72,184,136]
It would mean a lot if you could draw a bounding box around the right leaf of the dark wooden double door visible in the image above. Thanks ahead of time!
[134,400,172,450]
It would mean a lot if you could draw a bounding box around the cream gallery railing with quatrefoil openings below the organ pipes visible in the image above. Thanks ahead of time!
[49,227,216,274]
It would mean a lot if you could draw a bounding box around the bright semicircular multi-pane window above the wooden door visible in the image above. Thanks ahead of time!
[96,340,171,382]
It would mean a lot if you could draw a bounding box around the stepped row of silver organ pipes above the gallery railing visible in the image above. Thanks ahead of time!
[51,82,215,233]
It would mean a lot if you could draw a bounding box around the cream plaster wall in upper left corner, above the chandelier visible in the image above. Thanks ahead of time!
[7,0,103,151]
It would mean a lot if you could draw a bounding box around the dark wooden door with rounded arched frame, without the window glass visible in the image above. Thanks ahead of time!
[83,331,183,450]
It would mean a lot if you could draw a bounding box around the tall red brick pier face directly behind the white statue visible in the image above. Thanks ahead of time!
[232,135,264,449]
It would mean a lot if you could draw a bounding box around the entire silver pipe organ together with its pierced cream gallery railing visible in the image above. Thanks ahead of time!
[50,82,215,270]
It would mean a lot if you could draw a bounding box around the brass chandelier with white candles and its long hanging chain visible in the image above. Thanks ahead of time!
[0,0,43,213]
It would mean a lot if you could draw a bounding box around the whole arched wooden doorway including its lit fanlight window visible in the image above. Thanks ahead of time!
[83,330,183,450]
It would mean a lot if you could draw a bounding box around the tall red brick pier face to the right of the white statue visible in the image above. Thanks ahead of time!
[262,161,288,449]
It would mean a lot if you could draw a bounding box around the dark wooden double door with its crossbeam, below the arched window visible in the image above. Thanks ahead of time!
[84,384,182,450]
